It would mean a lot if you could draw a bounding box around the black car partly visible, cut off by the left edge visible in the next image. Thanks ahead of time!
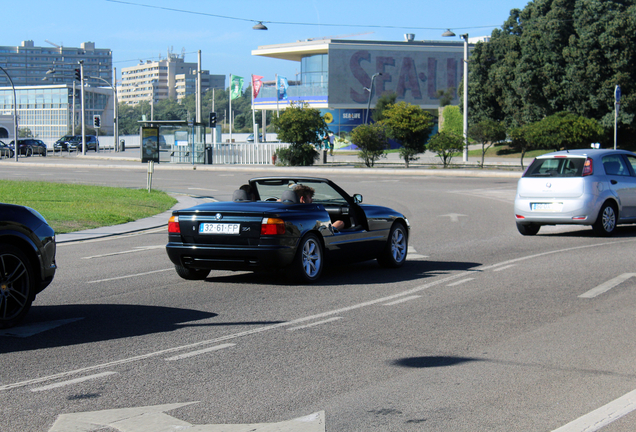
[0,203,57,328]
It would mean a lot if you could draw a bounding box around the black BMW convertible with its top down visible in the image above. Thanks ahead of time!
[166,177,410,283]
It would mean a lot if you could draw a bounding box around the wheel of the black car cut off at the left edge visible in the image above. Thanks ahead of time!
[0,244,35,328]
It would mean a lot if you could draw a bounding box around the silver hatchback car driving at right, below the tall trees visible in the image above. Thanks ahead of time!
[515,149,636,236]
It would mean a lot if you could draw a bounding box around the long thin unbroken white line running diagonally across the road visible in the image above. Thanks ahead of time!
[0,239,636,391]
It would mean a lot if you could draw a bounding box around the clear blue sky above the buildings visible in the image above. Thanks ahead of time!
[6,0,528,85]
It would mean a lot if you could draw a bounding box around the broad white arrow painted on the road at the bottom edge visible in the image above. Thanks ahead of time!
[49,402,325,432]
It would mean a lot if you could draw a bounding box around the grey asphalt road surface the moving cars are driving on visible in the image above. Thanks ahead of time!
[0,164,636,432]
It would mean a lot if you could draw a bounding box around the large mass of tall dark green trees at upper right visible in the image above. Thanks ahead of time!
[469,0,636,142]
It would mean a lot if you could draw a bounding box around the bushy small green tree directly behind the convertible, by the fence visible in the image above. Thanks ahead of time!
[272,103,328,166]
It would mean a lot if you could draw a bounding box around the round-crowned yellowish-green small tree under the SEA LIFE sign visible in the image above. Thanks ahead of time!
[380,102,434,168]
